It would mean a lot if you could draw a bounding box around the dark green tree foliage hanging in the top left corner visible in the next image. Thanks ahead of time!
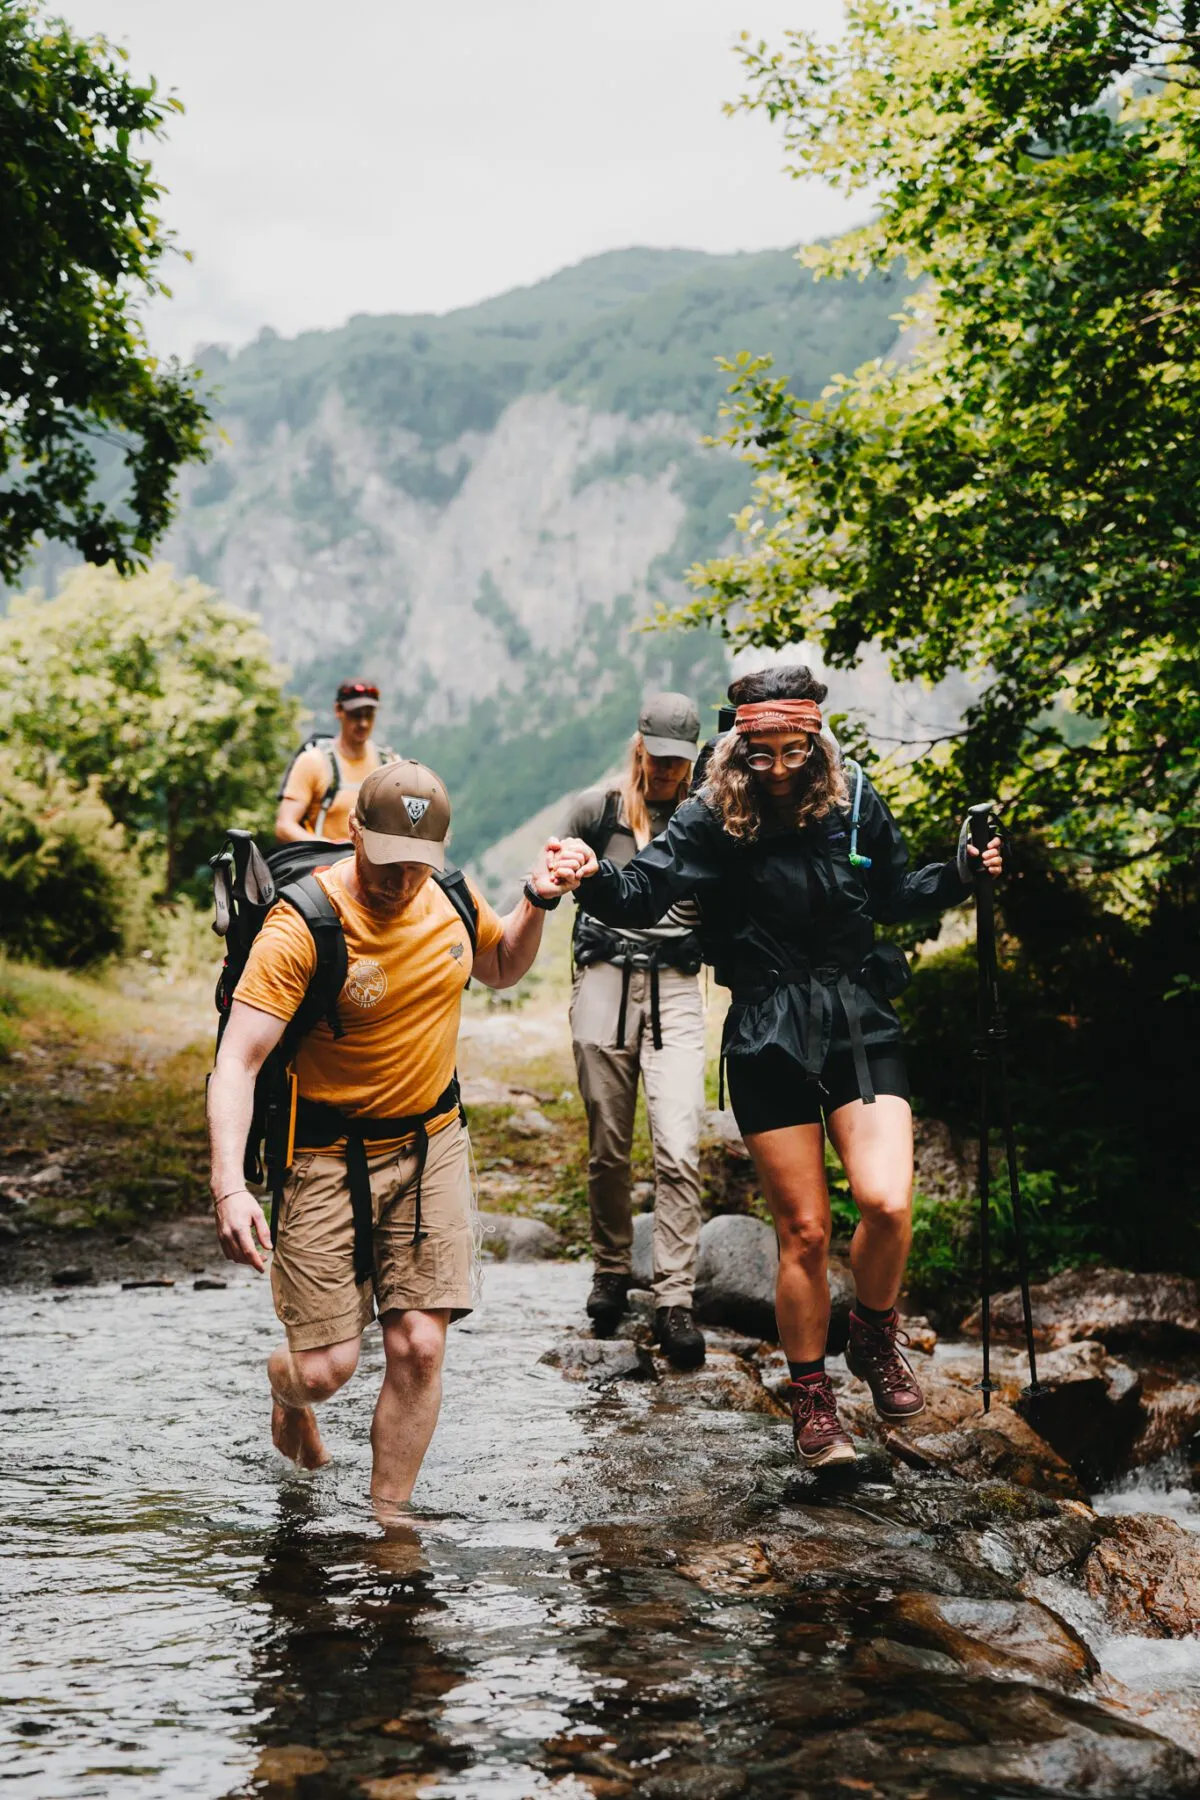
[0,4,209,581]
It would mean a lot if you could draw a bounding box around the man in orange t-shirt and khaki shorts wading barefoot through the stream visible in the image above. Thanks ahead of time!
[209,761,597,1510]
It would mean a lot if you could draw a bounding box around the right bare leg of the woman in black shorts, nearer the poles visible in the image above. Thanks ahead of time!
[829,1094,912,1312]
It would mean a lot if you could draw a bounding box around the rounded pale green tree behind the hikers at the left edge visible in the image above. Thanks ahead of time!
[0,563,299,895]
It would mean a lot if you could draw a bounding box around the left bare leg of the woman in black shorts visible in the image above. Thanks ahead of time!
[747,1125,829,1363]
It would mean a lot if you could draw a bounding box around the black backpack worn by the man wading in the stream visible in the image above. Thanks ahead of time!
[209,830,479,1237]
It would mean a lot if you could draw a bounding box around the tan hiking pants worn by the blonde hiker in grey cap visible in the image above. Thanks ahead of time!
[570,963,703,1307]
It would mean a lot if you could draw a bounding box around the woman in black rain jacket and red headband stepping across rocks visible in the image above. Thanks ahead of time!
[561,666,1000,1465]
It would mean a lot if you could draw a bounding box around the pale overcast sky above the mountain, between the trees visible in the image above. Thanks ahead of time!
[56,0,862,355]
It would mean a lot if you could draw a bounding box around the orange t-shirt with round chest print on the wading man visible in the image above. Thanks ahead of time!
[234,859,504,1150]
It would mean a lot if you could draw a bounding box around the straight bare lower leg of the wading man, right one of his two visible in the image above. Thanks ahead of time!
[371,1309,450,1517]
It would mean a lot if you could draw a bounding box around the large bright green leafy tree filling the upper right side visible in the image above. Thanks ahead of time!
[687,0,1200,889]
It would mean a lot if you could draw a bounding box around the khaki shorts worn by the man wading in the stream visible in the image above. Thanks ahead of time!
[272,1116,475,1350]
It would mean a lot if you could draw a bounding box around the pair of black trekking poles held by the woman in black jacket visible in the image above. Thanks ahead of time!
[968,801,1045,1413]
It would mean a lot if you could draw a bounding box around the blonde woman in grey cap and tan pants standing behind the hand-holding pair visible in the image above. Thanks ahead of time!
[563,693,705,1368]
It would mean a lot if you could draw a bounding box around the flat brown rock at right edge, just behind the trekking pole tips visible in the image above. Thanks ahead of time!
[963,1269,1200,1350]
